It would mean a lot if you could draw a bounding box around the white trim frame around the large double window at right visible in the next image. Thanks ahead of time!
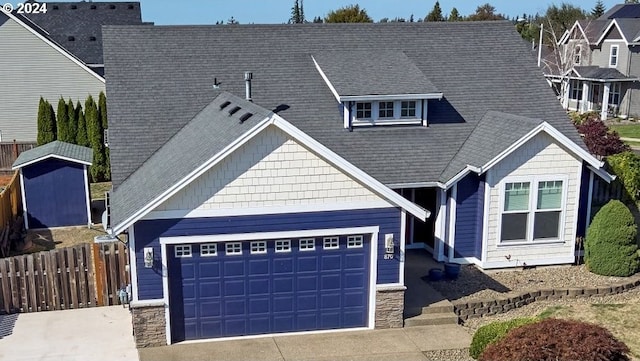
[496,174,569,247]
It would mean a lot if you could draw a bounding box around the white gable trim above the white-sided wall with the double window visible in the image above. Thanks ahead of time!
[445,122,615,189]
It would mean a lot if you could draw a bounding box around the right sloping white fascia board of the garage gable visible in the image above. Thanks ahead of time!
[274,114,431,221]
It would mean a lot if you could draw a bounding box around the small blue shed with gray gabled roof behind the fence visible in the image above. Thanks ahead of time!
[12,141,93,229]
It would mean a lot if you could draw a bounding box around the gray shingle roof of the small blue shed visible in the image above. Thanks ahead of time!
[11,140,93,169]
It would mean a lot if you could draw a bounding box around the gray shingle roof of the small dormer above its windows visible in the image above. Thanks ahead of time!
[313,50,438,96]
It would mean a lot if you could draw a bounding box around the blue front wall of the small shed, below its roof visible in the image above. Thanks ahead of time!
[22,158,89,228]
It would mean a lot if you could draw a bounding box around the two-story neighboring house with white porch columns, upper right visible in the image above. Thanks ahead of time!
[543,4,640,120]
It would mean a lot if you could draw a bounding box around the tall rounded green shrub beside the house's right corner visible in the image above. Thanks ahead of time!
[584,200,640,277]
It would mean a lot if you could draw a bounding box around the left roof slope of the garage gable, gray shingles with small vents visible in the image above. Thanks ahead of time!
[111,93,271,224]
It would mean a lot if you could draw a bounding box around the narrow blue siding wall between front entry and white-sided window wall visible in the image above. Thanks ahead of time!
[454,174,484,259]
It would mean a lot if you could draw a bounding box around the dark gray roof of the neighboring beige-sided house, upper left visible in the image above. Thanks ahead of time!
[24,1,142,64]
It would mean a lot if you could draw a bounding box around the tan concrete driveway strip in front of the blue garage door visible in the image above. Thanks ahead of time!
[139,325,471,361]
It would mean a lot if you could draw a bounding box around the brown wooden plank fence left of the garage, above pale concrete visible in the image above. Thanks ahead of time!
[0,242,129,313]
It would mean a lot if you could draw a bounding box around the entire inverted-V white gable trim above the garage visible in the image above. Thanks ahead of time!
[111,114,430,234]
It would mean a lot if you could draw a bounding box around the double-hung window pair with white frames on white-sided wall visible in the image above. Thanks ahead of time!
[500,179,566,243]
